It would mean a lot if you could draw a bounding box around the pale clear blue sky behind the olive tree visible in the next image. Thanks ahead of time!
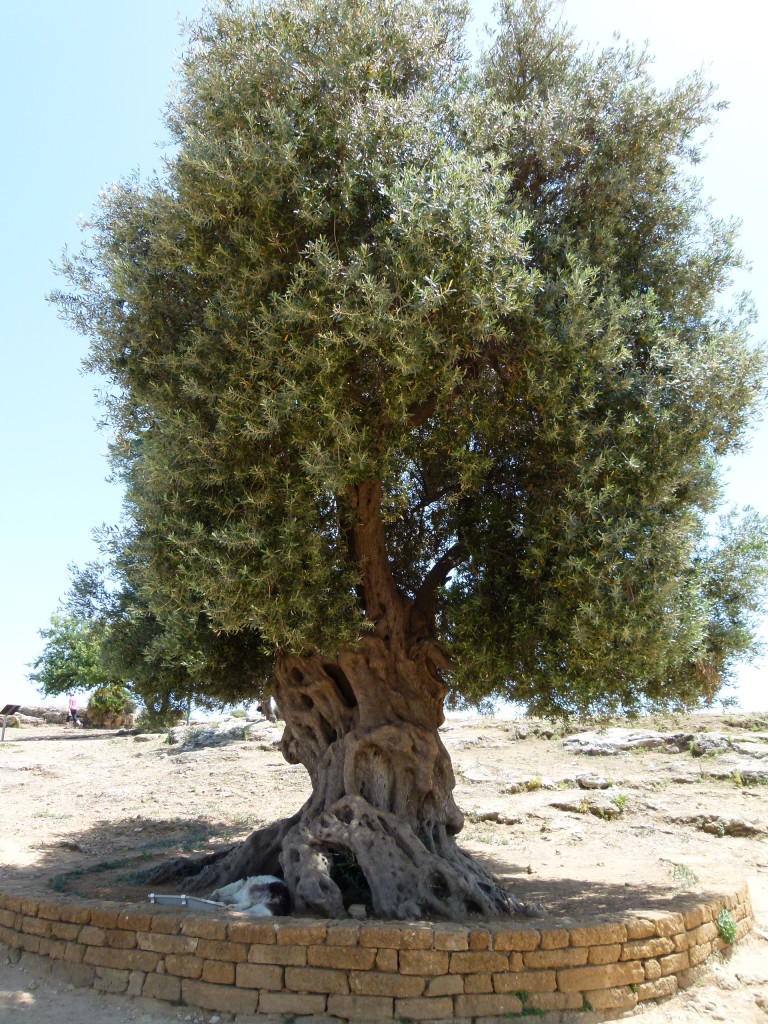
[0,0,768,709]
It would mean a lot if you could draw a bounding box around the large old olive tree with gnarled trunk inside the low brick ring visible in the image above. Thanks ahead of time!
[57,0,766,918]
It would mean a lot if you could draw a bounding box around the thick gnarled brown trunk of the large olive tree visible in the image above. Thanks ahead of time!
[152,484,524,919]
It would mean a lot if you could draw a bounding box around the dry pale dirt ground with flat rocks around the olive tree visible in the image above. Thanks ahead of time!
[0,715,768,1024]
